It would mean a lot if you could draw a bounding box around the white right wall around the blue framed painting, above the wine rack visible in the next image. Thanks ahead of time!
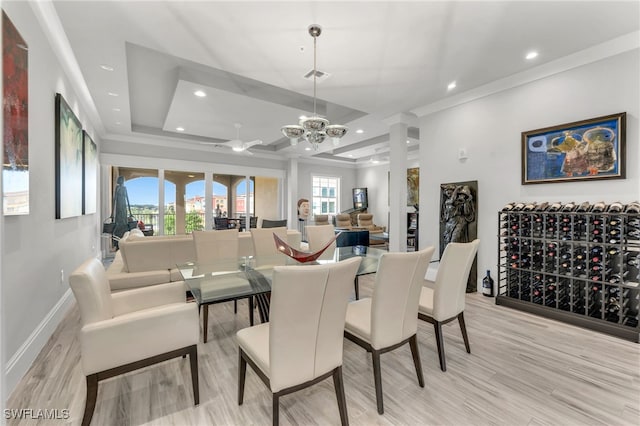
[420,49,640,292]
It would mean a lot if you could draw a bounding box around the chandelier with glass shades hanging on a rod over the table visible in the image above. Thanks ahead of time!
[281,24,348,151]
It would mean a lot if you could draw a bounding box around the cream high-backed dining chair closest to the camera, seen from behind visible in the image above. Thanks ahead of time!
[237,257,361,425]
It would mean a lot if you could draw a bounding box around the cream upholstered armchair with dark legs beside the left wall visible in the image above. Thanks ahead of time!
[69,258,200,426]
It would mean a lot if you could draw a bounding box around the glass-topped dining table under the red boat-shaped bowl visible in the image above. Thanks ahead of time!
[177,246,387,343]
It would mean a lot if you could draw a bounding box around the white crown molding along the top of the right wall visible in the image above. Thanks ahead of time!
[411,31,640,118]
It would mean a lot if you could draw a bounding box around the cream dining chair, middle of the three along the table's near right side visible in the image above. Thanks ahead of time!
[344,247,434,414]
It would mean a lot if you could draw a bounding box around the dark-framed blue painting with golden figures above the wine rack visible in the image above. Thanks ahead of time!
[522,112,627,185]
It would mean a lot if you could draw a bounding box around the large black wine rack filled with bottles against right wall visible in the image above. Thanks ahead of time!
[496,203,640,342]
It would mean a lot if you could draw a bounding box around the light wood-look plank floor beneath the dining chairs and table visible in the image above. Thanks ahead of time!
[7,277,640,426]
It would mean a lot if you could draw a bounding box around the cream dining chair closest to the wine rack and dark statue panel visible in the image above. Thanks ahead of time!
[418,239,480,371]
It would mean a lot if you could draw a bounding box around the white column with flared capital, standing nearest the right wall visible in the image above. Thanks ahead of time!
[385,113,415,252]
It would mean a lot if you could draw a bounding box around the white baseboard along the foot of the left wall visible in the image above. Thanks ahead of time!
[5,289,75,397]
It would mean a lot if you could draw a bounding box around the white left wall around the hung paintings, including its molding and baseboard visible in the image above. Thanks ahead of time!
[1,2,100,393]
